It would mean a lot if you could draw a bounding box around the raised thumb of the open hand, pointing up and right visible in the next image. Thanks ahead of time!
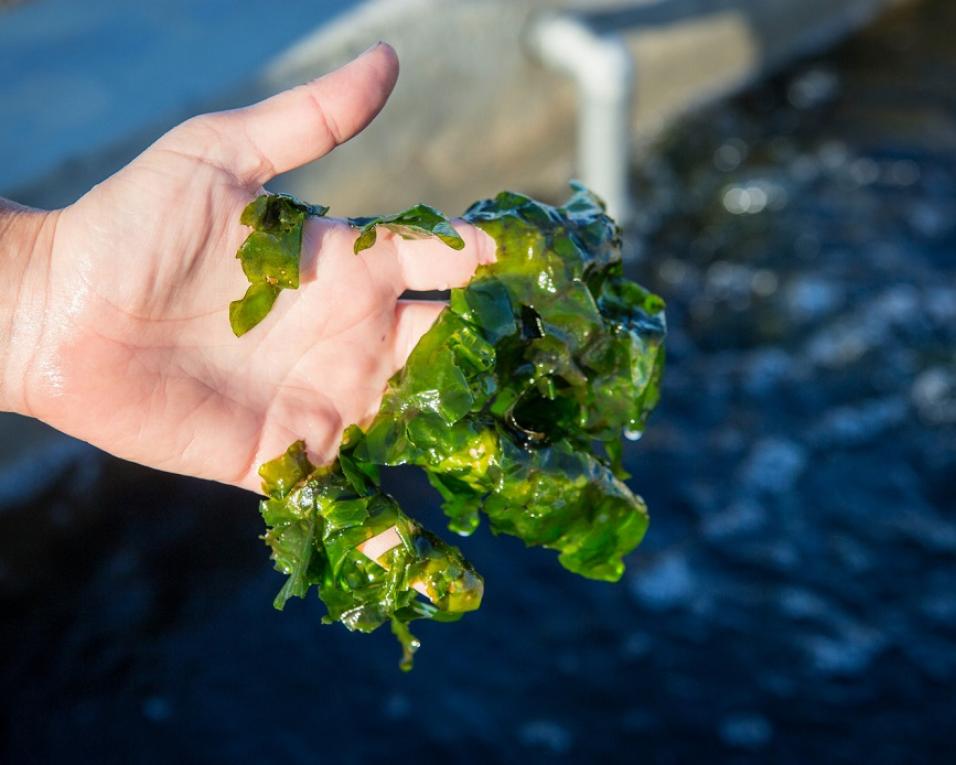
[167,42,398,187]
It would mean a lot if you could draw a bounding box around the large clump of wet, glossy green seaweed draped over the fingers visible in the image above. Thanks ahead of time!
[247,184,665,668]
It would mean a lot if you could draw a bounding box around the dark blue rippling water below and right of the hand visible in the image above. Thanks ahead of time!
[0,0,956,764]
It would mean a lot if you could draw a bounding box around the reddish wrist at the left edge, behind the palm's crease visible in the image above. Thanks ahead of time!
[0,199,59,414]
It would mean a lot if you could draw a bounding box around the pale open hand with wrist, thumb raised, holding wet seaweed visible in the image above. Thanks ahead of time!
[0,43,494,491]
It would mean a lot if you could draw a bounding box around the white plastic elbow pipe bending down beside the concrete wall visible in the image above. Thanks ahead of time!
[529,15,634,223]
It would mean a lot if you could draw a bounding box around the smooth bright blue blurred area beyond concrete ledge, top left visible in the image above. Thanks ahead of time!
[0,0,357,195]
